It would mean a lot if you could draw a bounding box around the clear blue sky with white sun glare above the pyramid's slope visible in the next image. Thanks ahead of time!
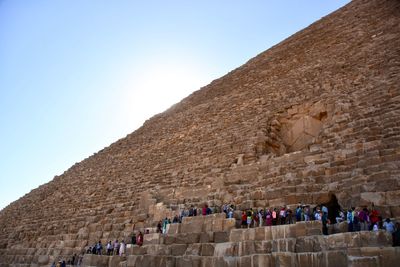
[0,0,349,209]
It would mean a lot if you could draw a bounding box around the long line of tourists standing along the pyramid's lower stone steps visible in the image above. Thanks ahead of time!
[57,204,400,267]
